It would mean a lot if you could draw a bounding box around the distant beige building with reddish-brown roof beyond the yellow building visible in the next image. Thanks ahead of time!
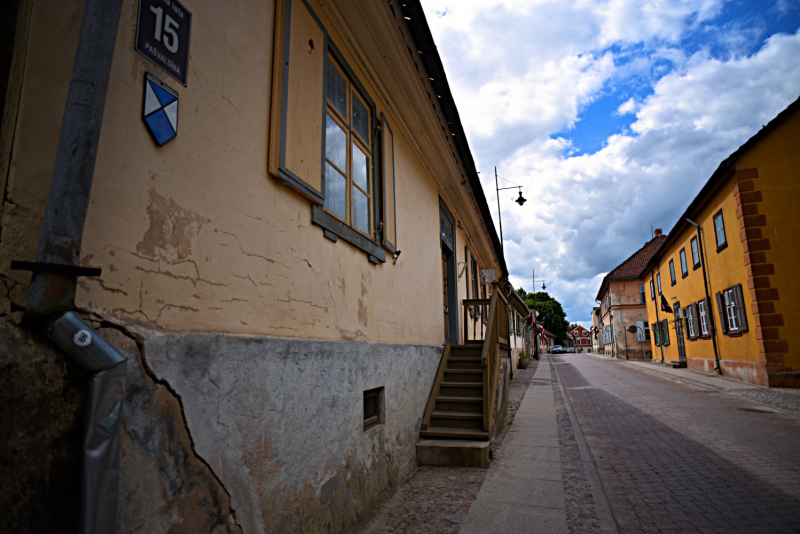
[596,236,666,360]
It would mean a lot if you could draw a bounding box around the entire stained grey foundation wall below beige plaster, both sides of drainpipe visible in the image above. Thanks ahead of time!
[0,317,442,534]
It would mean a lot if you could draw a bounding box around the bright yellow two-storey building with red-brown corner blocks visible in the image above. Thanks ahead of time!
[646,97,800,387]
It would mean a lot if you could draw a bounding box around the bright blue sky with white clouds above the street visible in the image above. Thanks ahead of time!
[422,0,800,325]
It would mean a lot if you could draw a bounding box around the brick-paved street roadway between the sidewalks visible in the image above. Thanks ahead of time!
[553,354,800,533]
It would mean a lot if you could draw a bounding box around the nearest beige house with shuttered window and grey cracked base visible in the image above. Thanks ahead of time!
[0,0,516,534]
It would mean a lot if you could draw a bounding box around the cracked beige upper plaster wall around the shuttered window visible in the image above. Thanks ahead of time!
[0,0,482,344]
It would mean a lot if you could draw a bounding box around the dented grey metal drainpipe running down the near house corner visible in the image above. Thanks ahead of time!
[18,0,126,534]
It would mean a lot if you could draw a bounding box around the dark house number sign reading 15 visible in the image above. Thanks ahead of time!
[136,0,192,87]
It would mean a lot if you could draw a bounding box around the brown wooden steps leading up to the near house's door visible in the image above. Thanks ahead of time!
[420,344,489,441]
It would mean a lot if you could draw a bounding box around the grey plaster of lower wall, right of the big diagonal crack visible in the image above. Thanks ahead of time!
[144,334,442,533]
